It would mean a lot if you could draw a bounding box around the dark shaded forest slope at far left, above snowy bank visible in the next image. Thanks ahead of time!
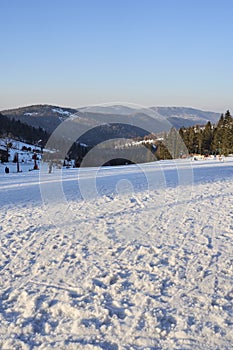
[0,113,49,146]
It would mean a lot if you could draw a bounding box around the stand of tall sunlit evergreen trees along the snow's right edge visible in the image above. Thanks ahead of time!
[156,110,233,159]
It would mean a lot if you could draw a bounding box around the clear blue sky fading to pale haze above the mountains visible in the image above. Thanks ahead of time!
[0,0,233,112]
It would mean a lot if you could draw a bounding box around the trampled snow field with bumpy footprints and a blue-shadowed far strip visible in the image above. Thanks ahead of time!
[0,157,233,350]
